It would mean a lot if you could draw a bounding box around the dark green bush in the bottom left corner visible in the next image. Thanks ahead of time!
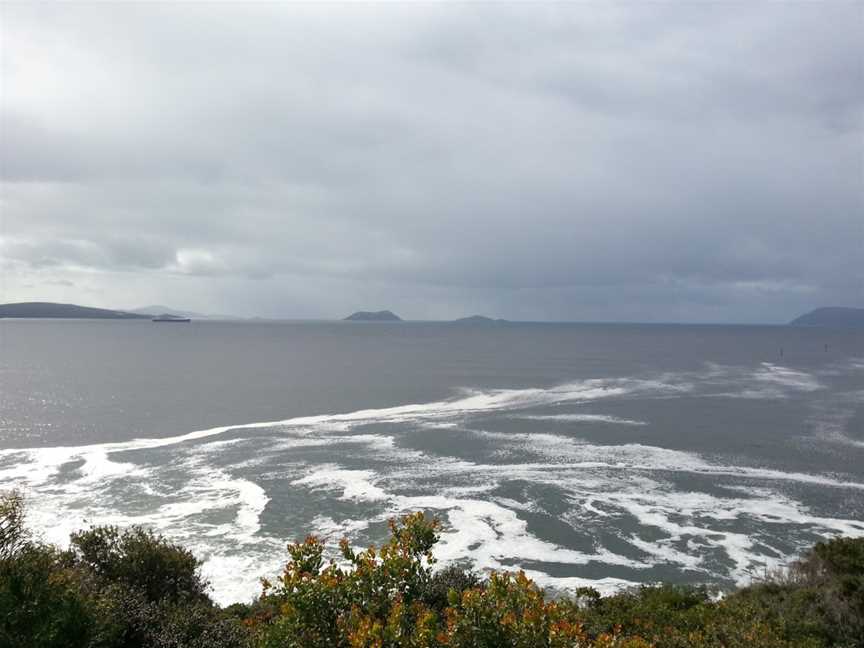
[0,494,248,648]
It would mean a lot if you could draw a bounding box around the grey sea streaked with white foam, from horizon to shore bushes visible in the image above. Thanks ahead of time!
[0,320,864,603]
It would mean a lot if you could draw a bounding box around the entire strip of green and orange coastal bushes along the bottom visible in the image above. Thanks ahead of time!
[0,492,864,648]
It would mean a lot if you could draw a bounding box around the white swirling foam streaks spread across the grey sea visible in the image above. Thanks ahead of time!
[0,364,864,604]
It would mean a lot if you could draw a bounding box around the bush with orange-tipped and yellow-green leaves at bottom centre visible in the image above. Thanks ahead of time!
[254,513,647,648]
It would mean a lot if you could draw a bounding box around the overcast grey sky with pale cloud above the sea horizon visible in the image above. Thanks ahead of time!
[0,2,864,323]
